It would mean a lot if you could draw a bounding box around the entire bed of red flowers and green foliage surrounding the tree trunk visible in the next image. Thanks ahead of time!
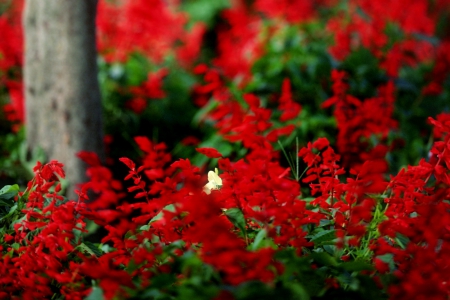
[0,0,450,299]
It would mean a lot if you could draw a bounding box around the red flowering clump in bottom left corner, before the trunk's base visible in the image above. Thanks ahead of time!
[0,161,89,299]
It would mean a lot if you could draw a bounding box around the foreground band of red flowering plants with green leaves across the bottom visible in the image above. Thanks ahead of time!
[0,119,450,299]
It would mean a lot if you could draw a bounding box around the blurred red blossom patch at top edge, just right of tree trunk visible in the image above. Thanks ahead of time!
[97,0,205,64]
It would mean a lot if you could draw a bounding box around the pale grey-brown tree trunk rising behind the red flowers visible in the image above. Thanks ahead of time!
[23,0,104,197]
